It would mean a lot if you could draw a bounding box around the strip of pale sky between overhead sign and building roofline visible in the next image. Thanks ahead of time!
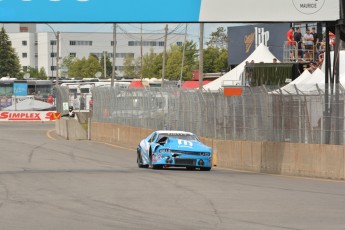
[37,23,243,43]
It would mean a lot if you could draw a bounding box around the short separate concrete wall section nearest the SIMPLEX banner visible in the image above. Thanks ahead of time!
[55,117,87,140]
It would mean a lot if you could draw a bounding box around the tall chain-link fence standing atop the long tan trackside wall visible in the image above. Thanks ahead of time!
[53,85,345,145]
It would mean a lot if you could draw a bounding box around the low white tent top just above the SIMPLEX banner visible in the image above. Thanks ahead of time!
[3,99,55,111]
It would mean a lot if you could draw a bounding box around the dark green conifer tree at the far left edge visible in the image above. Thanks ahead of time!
[0,27,21,77]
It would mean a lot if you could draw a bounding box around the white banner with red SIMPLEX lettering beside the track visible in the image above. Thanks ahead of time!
[0,111,56,121]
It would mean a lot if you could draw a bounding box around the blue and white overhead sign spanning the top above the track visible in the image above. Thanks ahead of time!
[0,0,340,23]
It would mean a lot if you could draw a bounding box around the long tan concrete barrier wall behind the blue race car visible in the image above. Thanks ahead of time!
[91,122,345,180]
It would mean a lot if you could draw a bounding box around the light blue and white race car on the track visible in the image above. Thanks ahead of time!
[137,130,212,171]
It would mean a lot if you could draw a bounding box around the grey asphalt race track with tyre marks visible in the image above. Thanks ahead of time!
[0,122,345,230]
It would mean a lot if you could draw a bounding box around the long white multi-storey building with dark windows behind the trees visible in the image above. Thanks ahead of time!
[4,24,184,78]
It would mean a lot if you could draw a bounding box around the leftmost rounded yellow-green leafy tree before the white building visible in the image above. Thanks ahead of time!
[68,55,102,79]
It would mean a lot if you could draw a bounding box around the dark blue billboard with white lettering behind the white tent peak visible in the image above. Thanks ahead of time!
[228,23,290,65]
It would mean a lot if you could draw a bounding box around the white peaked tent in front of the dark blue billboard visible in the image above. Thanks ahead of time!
[204,43,276,91]
